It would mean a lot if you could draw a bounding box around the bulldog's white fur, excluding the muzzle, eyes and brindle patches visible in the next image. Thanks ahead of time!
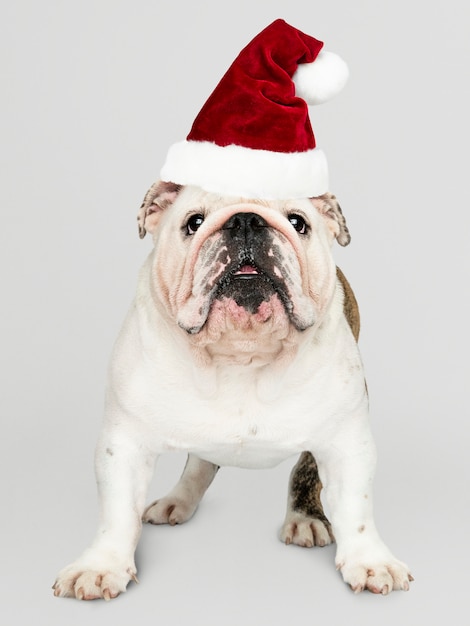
[55,189,408,599]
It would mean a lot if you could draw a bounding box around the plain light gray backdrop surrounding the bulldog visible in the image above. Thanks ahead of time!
[0,0,470,626]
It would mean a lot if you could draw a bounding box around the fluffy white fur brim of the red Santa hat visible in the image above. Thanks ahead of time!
[160,141,328,200]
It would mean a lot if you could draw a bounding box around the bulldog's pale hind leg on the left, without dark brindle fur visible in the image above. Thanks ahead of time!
[142,454,219,526]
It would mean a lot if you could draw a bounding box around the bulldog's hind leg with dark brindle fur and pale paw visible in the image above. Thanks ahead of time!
[281,452,334,548]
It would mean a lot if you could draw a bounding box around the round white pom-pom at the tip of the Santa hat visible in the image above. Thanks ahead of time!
[292,50,349,104]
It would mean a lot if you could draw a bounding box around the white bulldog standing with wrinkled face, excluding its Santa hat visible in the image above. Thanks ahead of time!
[53,182,412,600]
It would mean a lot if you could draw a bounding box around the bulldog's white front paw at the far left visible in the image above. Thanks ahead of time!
[52,559,138,600]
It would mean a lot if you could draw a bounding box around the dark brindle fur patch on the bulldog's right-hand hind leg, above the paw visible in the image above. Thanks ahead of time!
[290,452,330,528]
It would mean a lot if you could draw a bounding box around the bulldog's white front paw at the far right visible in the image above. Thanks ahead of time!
[336,555,414,595]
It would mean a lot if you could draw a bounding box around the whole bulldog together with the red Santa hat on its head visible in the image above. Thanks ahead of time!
[54,20,412,600]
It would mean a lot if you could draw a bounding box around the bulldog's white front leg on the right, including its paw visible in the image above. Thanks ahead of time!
[315,416,413,595]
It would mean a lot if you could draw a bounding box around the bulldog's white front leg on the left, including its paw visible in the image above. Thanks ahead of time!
[53,429,155,600]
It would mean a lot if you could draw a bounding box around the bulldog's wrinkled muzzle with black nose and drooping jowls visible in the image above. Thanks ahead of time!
[174,211,314,334]
